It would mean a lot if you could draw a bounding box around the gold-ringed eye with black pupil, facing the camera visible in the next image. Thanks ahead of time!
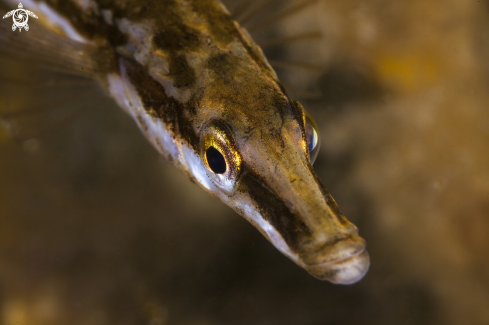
[200,120,242,193]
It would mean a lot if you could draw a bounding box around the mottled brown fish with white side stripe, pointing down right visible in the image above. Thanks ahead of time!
[0,0,370,284]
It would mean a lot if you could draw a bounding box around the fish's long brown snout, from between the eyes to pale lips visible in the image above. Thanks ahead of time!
[230,116,370,284]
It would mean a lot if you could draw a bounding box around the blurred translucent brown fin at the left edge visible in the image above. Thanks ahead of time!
[0,22,112,142]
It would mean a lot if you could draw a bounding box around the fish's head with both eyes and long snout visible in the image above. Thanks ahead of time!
[193,62,369,284]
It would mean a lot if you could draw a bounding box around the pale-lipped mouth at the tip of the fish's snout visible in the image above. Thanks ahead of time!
[303,235,370,284]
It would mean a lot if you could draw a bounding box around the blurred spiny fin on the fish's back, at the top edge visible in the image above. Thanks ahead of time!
[223,0,327,99]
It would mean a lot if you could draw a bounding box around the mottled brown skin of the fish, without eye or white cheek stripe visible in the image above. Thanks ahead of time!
[32,0,368,283]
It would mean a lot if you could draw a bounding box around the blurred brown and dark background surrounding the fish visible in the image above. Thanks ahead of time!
[0,0,489,325]
